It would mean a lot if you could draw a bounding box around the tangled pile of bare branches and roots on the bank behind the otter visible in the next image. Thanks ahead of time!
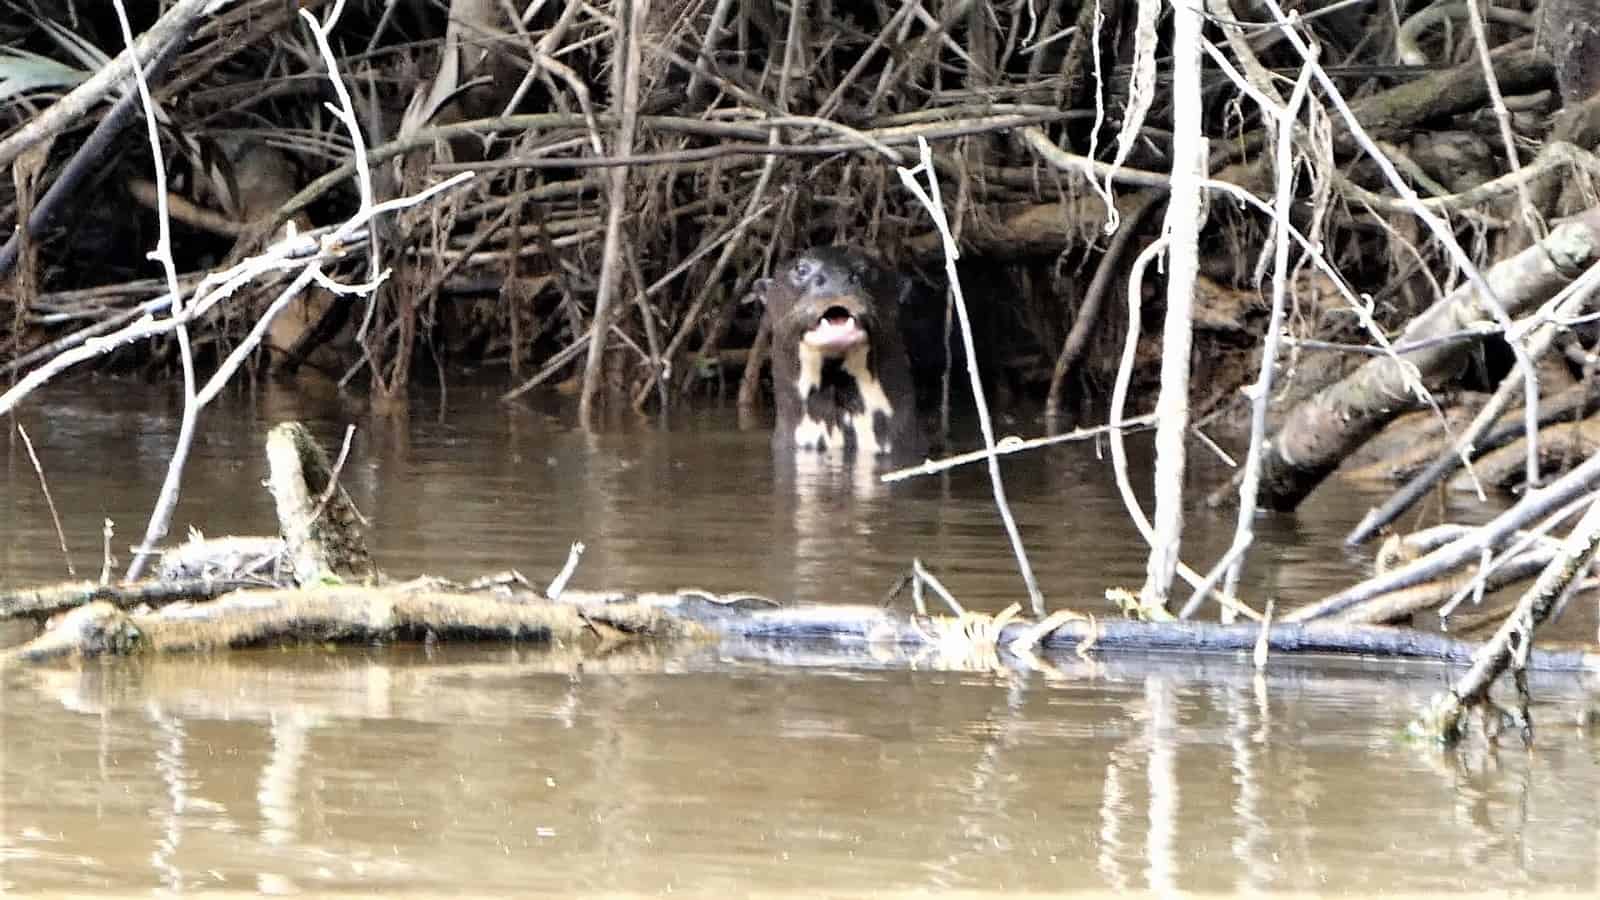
[0,0,1595,425]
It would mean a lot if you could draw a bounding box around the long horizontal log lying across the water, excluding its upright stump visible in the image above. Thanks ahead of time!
[0,576,1600,671]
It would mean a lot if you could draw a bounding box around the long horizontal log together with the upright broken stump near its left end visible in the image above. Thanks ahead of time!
[0,423,1600,688]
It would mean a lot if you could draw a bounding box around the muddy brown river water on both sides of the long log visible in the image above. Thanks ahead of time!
[0,380,1600,897]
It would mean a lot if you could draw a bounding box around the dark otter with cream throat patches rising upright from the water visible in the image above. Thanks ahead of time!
[755,247,926,460]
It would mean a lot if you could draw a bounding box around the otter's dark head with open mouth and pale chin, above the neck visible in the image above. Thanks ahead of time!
[752,247,910,359]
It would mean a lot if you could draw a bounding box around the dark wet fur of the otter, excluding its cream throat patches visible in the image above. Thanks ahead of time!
[757,247,928,460]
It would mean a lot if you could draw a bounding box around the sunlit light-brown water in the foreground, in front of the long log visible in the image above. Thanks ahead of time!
[3,647,1600,895]
